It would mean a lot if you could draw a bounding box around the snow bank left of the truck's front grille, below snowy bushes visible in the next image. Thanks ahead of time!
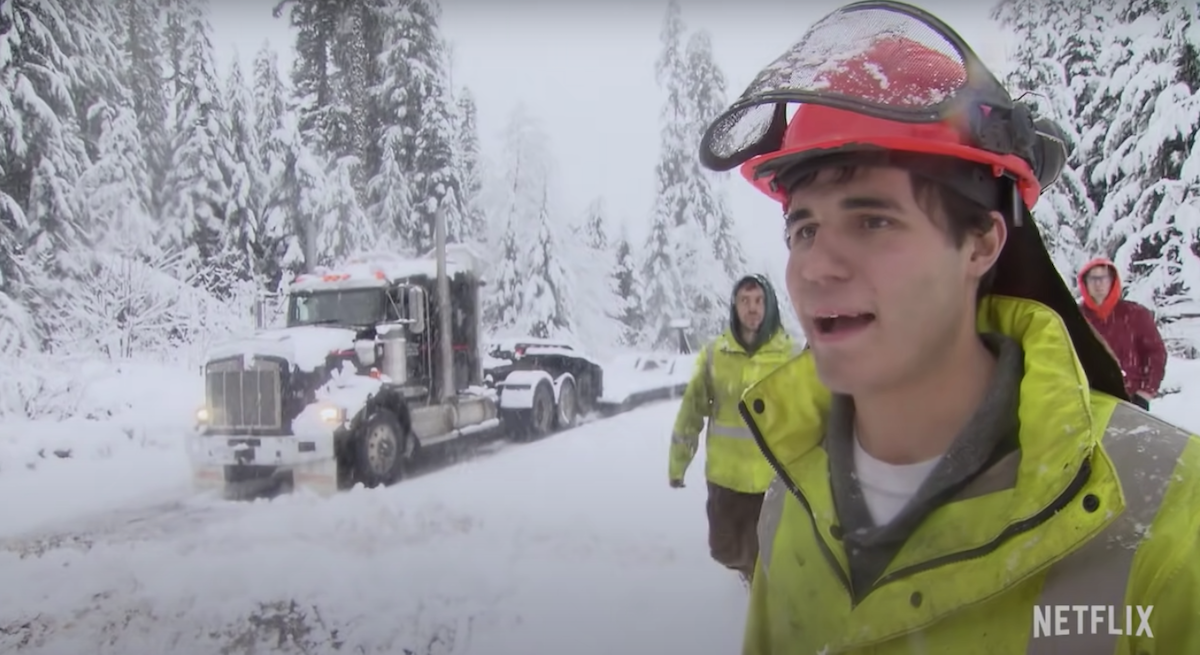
[0,362,203,537]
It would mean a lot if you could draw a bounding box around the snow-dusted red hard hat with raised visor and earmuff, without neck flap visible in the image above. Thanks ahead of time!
[700,0,1066,217]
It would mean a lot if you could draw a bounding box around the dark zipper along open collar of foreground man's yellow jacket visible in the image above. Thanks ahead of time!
[738,401,1092,609]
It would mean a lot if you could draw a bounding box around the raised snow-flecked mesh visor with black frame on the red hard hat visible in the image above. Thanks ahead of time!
[700,0,1066,206]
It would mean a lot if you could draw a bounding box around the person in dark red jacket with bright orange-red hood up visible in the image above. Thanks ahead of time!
[1079,258,1166,409]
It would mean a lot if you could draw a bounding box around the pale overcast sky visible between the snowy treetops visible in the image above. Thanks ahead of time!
[210,0,1009,274]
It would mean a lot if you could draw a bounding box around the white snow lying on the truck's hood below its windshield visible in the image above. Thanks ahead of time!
[206,325,356,371]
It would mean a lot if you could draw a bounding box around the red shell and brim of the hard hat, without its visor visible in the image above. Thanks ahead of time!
[742,37,1040,206]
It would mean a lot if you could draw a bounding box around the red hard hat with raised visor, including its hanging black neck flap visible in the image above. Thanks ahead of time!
[700,0,1127,398]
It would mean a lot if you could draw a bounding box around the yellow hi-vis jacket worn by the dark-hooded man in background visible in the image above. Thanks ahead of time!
[668,330,798,493]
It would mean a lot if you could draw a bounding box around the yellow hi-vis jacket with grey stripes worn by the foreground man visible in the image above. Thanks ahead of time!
[742,296,1200,655]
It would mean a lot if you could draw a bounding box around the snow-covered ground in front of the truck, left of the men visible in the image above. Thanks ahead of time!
[0,402,746,655]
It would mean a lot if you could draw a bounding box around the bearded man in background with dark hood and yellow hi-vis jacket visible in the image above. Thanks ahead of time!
[668,275,792,583]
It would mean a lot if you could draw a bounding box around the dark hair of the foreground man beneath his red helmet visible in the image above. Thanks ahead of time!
[776,152,1006,302]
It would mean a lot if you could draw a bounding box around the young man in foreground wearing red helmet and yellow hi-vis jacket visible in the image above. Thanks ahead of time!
[701,1,1200,655]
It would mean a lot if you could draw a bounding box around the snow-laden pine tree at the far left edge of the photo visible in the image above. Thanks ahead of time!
[0,0,92,343]
